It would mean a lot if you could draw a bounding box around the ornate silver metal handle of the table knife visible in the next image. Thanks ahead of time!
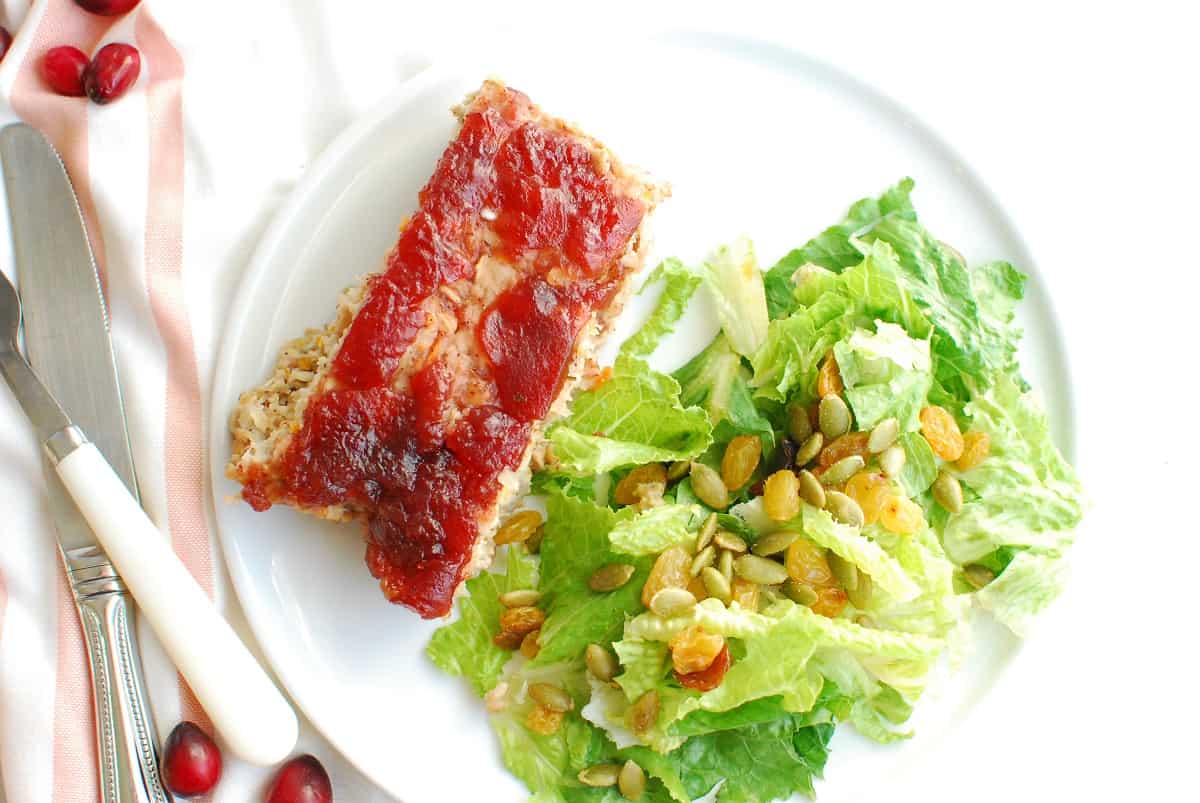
[62,547,172,803]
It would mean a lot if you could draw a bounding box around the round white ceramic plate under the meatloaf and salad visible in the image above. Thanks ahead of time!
[211,36,1072,803]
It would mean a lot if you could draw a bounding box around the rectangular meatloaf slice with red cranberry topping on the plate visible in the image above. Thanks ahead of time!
[226,80,665,617]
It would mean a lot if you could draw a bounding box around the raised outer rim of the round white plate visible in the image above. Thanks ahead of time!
[208,28,1078,795]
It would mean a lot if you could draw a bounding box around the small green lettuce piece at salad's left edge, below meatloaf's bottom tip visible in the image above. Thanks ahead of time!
[425,547,538,696]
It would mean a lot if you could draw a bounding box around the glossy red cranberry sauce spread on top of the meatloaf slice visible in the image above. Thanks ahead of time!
[268,88,644,617]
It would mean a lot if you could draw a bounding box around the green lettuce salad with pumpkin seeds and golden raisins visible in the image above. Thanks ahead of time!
[428,180,1084,803]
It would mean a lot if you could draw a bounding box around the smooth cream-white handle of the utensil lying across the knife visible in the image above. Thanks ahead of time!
[46,427,299,766]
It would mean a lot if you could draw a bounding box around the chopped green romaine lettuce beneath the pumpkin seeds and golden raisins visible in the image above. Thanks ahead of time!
[428,179,1085,803]
